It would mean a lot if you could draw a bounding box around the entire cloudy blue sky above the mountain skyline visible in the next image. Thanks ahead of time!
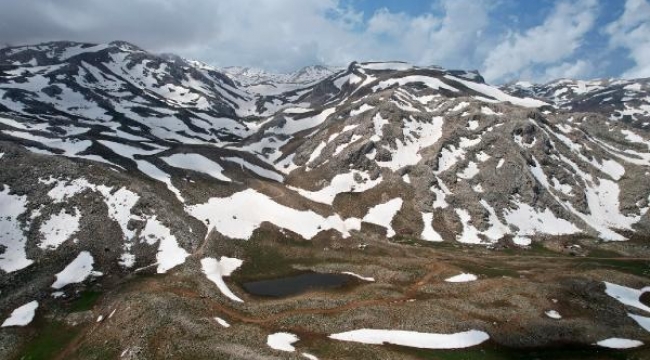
[0,0,650,83]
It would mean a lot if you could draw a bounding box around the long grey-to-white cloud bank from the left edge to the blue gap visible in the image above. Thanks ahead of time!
[0,0,489,71]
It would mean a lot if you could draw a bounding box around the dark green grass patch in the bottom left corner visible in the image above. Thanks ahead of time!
[16,321,80,360]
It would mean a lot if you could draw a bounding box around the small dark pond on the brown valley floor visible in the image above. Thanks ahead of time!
[242,272,353,297]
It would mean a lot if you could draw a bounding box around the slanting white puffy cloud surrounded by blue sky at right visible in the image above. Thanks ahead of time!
[483,0,598,81]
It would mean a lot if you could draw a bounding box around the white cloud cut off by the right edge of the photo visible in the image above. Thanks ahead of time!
[606,0,650,78]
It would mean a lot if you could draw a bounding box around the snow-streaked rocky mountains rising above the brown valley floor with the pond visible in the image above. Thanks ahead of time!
[0,42,650,358]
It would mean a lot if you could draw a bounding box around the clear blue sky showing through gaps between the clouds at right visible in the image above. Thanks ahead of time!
[334,0,650,82]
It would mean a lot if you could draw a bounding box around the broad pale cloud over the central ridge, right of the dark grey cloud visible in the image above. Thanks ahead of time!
[195,0,490,70]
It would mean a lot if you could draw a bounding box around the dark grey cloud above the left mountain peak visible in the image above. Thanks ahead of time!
[0,0,219,51]
